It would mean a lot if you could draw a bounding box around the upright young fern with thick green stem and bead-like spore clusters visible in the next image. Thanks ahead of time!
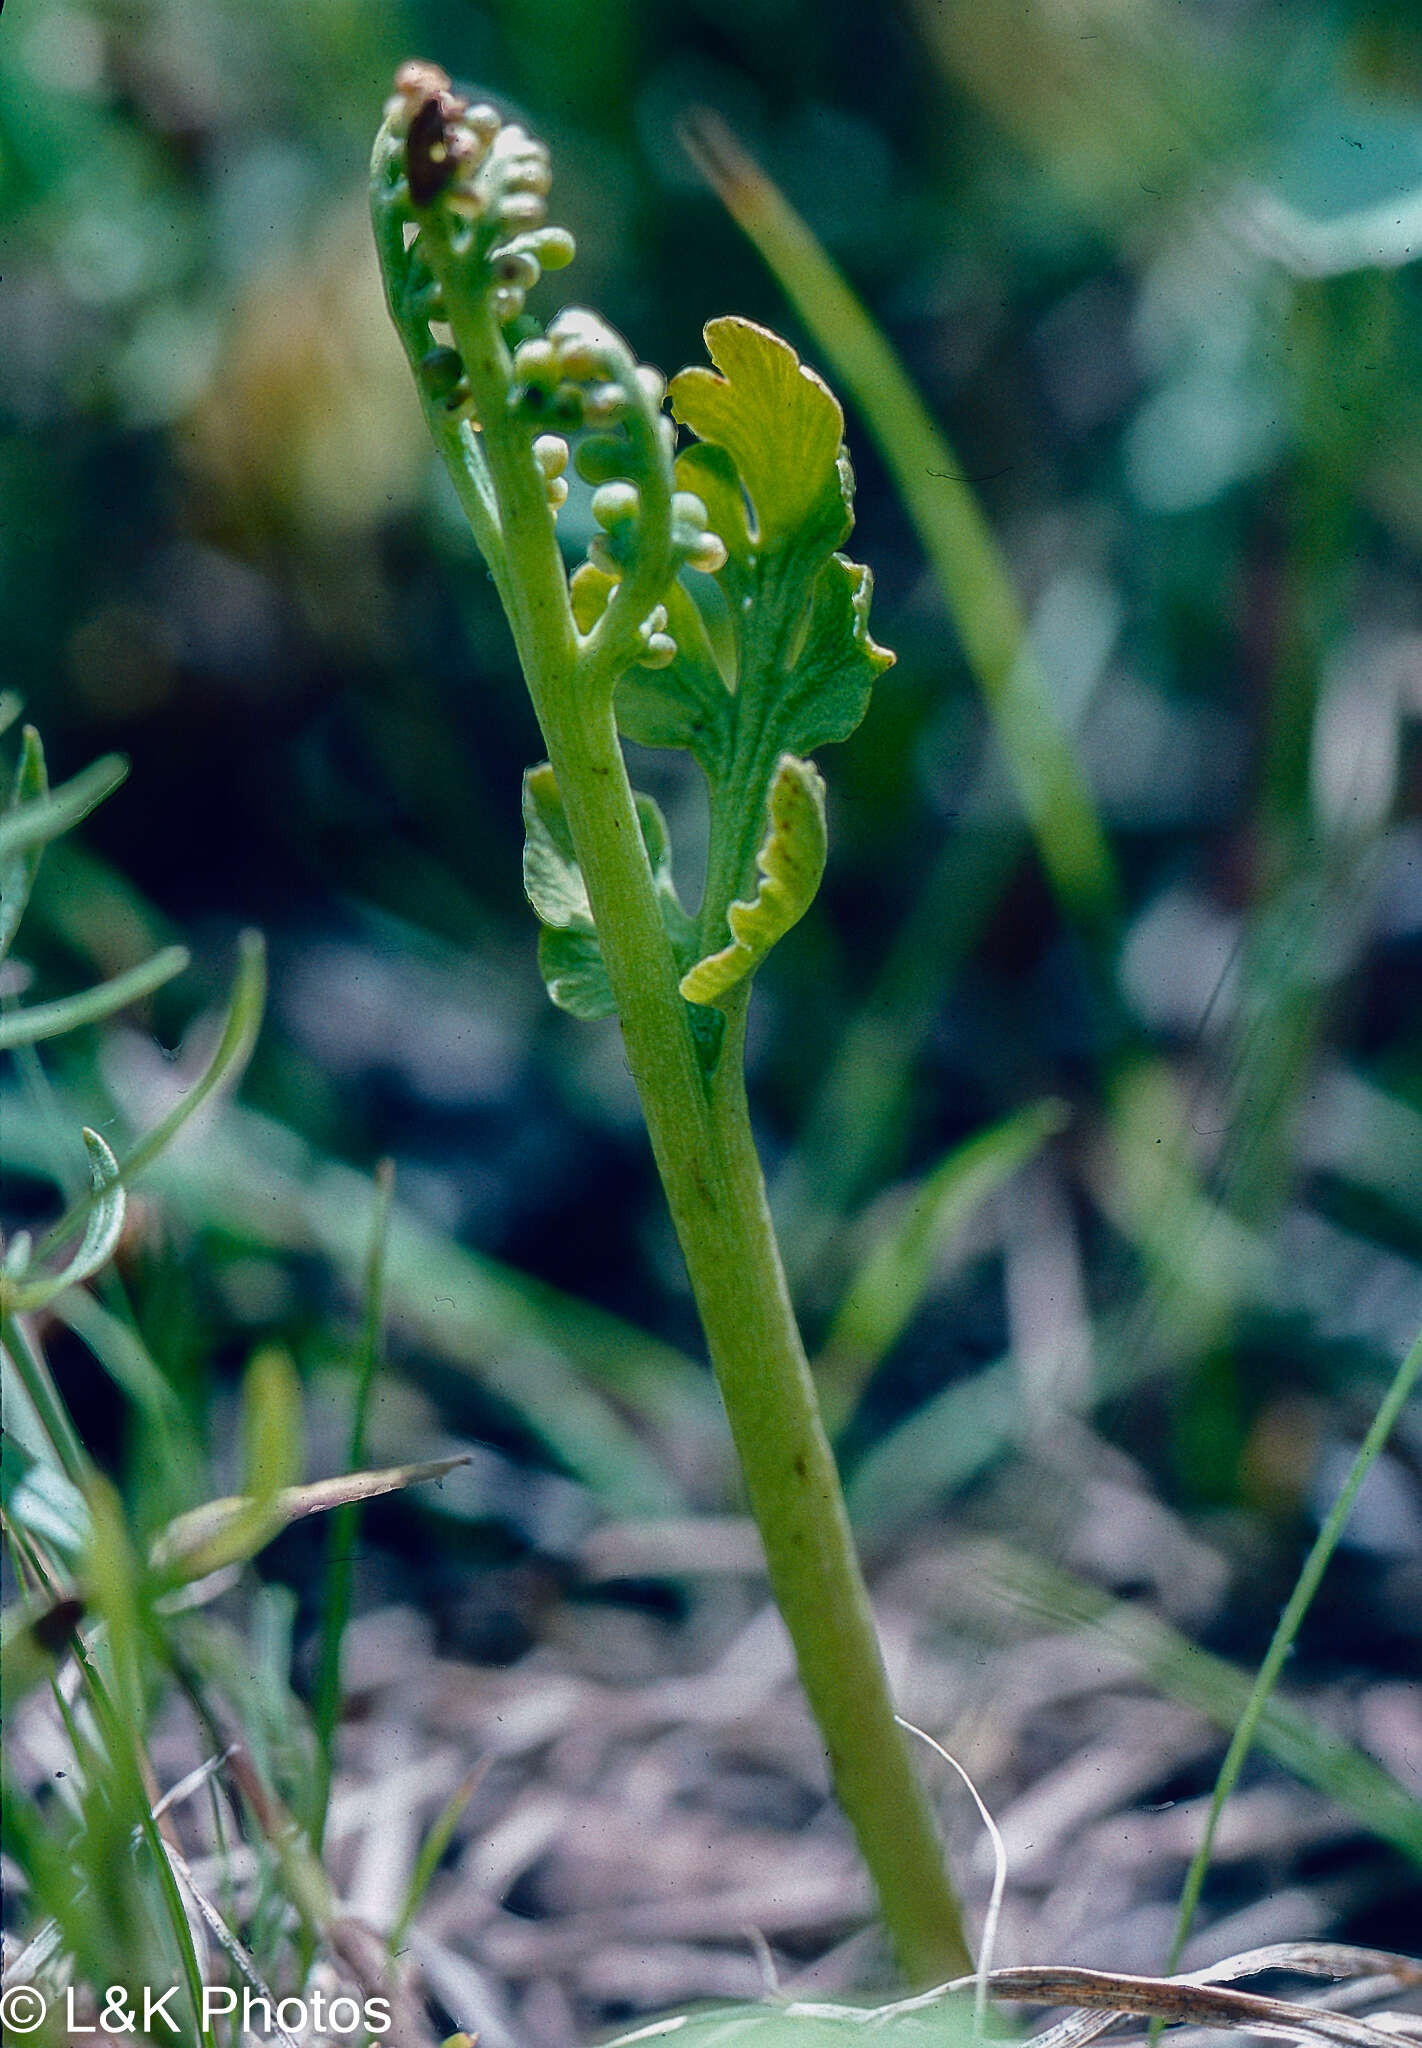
[371,63,969,1982]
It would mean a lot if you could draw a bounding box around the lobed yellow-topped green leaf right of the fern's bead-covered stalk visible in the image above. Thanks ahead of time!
[639,319,893,1004]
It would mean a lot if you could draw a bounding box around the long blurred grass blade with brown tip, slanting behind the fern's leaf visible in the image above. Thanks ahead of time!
[686,113,1119,938]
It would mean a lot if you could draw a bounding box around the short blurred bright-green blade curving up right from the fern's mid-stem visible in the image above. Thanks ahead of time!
[815,1102,1068,1432]
